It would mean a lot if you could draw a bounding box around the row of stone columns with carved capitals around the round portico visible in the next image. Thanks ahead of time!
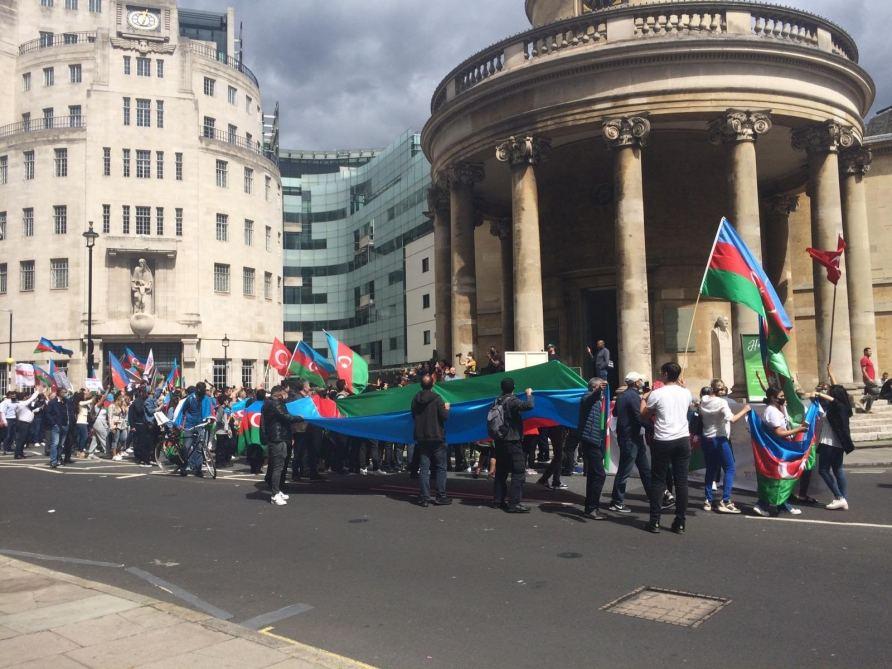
[431,109,876,388]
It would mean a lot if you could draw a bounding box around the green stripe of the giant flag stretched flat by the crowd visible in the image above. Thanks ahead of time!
[337,361,587,416]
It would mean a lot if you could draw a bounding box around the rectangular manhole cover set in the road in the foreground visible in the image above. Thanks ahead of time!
[601,588,731,627]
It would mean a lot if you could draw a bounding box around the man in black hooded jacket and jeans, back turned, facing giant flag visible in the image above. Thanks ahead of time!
[412,374,452,507]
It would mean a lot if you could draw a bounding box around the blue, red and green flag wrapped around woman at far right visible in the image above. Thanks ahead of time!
[747,402,818,506]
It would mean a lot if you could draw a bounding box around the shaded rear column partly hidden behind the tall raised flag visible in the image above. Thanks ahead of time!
[763,195,799,376]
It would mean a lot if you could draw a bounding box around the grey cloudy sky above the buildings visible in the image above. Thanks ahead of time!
[188,0,892,149]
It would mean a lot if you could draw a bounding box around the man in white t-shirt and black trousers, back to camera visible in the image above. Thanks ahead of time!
[641,362,694,534]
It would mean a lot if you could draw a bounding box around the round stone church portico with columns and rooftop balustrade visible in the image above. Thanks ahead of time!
[422,0,880,383]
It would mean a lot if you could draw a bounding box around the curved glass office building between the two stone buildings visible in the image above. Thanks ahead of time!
[279,132,433,369]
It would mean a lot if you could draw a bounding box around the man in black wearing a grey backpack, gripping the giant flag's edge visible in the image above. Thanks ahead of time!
[486,377,533,513]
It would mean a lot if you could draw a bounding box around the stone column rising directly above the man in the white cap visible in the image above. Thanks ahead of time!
[603,116,652,379]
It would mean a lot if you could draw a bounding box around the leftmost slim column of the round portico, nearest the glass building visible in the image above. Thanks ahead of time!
[426,185,454,362]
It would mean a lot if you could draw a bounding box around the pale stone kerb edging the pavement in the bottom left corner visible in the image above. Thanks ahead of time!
[0,554,376,669]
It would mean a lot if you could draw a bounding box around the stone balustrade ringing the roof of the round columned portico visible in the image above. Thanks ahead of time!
[431,0,858,113]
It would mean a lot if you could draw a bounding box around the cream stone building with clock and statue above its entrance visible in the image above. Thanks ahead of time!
[0,0,282,384]
